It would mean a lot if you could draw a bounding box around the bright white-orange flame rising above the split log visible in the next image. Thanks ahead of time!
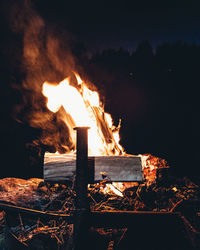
[42,73,124,155]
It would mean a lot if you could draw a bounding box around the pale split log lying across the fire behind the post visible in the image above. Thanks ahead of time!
[44,154,143,182]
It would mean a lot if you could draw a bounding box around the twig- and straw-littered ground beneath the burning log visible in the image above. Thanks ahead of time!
[0,156,200,250]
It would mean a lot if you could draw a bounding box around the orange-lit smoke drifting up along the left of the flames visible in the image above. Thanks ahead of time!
[5,0,79,152]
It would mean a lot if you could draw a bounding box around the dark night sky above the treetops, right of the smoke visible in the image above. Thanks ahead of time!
[35,0,200,50]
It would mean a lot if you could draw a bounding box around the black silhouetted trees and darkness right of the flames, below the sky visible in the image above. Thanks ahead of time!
[79,41,200,175]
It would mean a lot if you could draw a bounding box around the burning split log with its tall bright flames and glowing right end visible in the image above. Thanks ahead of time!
[42,73,167,190]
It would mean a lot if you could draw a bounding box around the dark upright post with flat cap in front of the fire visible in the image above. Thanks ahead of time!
[73,127,89,250]
